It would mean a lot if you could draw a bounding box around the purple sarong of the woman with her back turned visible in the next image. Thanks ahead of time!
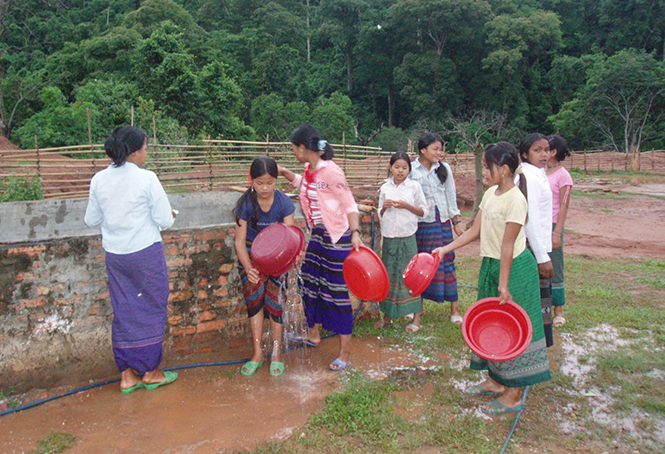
[106,242,169,374]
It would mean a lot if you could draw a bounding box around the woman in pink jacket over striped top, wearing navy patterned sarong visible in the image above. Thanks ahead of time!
[279,125,363,371]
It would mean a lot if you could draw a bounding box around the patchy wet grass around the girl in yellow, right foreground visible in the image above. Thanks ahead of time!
[237,256,665,454]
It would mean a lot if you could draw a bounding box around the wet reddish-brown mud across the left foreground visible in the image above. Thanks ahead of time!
[0,337,430,454]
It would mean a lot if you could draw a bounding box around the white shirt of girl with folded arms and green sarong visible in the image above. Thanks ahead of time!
[379,177,428,238]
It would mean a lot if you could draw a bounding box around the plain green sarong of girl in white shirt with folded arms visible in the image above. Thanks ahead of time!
[380,234,423,318]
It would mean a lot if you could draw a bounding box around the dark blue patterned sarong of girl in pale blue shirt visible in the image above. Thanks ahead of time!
[416,207,459,303]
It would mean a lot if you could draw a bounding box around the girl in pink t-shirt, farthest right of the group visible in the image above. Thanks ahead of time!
[545,135,573,326]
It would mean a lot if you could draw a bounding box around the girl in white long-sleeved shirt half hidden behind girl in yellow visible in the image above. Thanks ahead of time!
[518,133,554,347]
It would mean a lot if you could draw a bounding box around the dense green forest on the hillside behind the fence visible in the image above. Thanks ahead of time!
[0,0,665,152]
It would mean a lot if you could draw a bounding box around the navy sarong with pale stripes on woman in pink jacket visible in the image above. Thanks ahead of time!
[301,226,353,334]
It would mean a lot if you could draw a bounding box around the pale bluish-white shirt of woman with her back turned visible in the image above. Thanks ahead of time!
[84,162,174,254]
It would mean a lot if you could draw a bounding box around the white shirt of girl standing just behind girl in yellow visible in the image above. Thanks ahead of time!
[522,162,552,264]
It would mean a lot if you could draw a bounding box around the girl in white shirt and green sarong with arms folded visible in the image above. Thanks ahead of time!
[374,151,427,332]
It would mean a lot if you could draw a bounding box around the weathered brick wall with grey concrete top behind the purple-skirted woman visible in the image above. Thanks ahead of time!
[0,193,378,389]
